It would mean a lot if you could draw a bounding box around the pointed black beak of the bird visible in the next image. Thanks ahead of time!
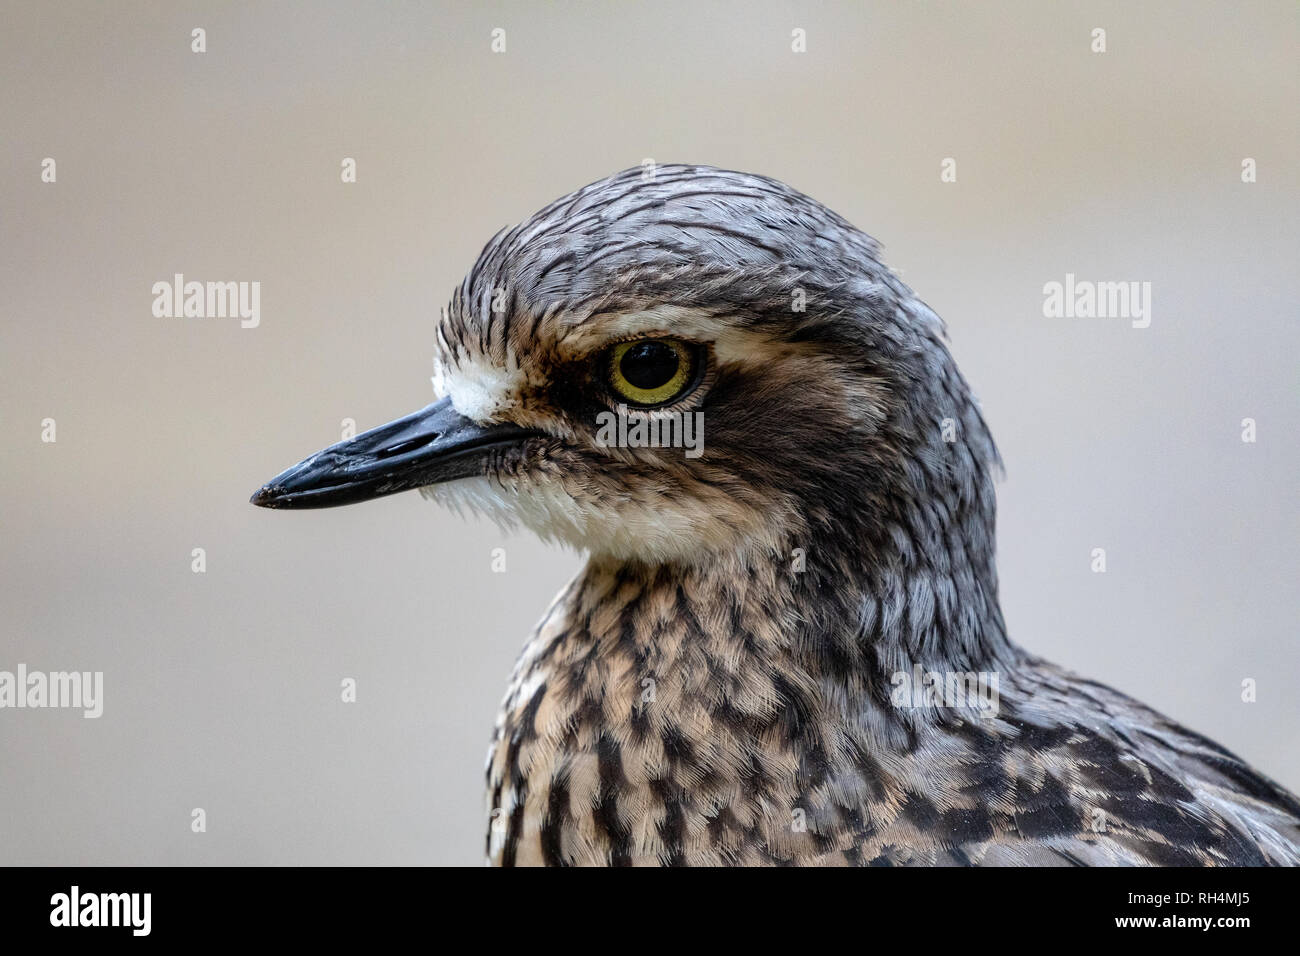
[250,398,540,509]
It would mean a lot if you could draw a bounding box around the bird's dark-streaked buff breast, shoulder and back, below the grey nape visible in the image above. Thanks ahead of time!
[488,568,1300,866]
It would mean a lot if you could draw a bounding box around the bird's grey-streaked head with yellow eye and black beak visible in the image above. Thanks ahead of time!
[252,165,996,564]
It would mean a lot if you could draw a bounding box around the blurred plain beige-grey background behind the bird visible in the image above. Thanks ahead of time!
[0,0,1300,865]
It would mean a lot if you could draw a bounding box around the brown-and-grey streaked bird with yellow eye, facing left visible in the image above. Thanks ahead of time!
[252,164,1300,866]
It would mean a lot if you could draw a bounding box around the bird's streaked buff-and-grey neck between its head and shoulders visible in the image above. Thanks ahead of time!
[577,522,1018,732]
